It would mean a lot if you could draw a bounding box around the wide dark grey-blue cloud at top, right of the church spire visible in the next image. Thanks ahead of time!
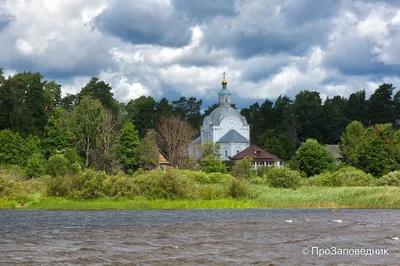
[200,0,339,58]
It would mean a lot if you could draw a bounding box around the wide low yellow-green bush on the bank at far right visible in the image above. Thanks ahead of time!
[306,166,375,187]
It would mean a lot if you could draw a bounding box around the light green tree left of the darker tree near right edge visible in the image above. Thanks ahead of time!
[339,121,365,167]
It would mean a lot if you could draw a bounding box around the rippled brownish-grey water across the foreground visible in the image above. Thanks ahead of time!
[0,209,400,265]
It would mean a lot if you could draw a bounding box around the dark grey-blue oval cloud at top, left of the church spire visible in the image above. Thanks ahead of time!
[95,0,191,47]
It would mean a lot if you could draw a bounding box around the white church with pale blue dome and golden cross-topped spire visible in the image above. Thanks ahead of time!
[189,73,250,160]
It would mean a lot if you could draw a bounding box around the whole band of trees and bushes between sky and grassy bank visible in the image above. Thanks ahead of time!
[0,68,400,206]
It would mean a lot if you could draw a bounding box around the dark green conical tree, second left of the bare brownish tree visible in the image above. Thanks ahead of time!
[117,122,139,171]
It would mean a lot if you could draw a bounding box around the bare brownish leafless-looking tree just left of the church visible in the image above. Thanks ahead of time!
[158,116,196,167]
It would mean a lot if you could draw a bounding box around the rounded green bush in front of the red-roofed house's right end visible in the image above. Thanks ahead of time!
[266,167,301,189]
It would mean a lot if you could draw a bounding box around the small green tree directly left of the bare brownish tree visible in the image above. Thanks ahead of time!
[135,130,160,170]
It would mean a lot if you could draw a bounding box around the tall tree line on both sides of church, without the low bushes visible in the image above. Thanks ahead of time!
[0,71,400,171]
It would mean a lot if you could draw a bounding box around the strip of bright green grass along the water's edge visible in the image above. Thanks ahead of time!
[0,185,400,210]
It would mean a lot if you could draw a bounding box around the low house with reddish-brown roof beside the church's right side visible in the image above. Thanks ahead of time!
[231,145,284,169]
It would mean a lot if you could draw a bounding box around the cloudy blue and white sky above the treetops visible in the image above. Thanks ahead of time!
[0,0,400,107]
